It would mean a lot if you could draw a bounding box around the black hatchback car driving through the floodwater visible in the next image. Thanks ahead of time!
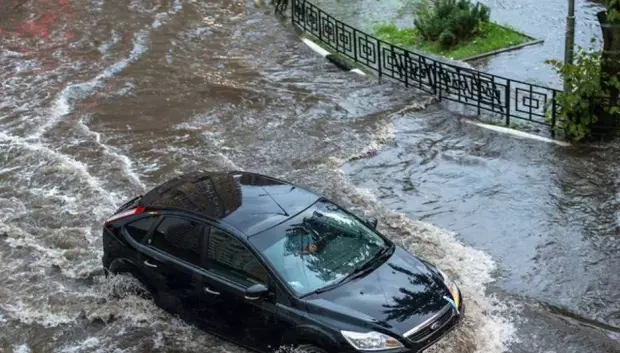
[102,172,463,352]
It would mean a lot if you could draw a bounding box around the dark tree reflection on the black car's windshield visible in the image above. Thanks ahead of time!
[284,211,378,282]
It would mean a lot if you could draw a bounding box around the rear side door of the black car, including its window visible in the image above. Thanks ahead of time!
[139,216,208,321]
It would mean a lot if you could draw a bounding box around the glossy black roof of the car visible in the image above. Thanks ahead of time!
[139,171,320,236]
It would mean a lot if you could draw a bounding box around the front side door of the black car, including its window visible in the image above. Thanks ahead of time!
[196,226,287,351]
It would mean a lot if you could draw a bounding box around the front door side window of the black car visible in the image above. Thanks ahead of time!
[207,227,269,287]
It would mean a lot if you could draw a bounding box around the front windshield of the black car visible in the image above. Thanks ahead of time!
[250,200,388,296]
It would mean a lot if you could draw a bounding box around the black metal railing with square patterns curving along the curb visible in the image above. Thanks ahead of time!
[274,0,572,136]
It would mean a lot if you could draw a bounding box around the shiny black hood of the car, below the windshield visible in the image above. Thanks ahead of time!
[306,247,450,335]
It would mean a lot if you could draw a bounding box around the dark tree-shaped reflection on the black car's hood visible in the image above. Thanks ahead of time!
[383,264,447,322]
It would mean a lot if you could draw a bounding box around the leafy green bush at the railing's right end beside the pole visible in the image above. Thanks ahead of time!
[546,39,620,142]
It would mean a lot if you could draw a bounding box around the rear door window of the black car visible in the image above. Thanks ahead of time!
[149,217,205,266]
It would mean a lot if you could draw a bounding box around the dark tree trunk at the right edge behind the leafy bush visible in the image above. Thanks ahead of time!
[592,11,620,139]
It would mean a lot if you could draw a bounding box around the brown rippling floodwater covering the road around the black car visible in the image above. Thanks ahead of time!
[0,0,620,353]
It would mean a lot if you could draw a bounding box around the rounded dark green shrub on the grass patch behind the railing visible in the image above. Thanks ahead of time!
[414,0,491,49]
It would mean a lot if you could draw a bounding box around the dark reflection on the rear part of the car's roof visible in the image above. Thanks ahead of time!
[155,174,242,219]
